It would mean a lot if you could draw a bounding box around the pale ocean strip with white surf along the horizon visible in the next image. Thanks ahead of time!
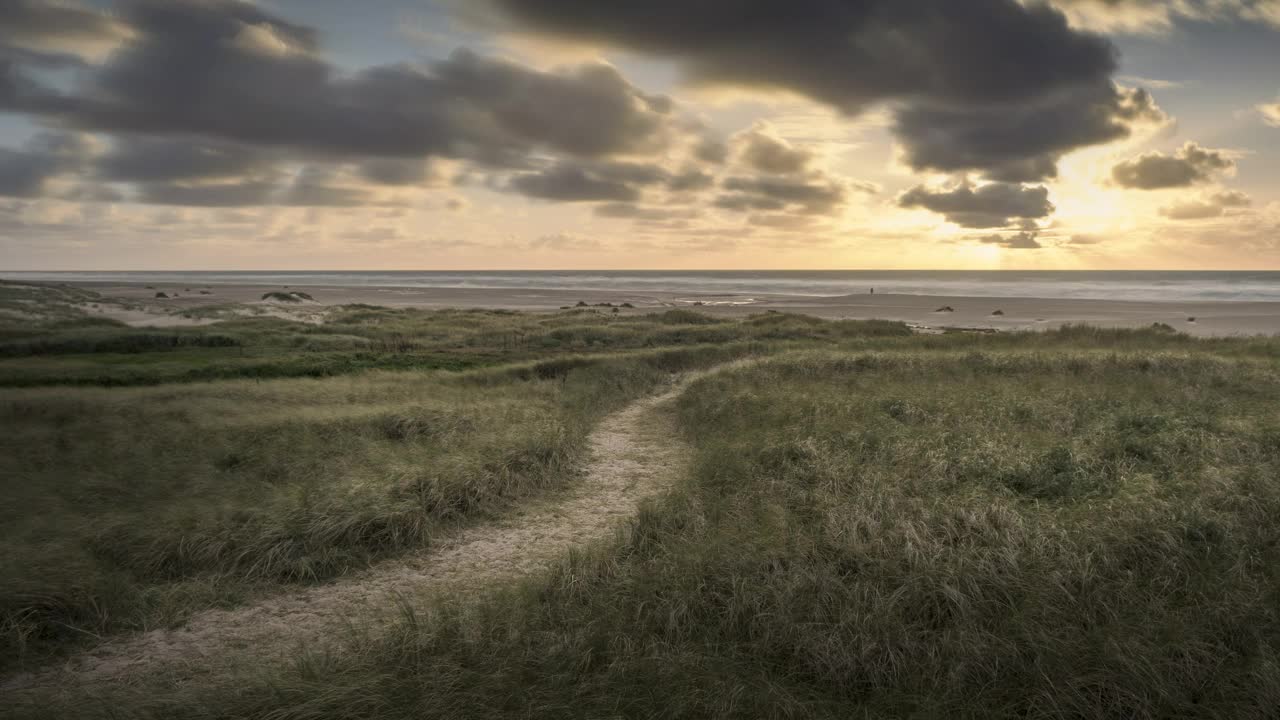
[0,270,1280,301]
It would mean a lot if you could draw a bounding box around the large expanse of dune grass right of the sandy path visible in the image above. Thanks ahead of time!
[45,333,1280,719]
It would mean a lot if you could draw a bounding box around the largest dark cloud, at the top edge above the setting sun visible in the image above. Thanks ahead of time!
[489,0,1160,181]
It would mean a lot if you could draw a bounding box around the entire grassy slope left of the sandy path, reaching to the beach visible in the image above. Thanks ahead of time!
[0,280,905,667]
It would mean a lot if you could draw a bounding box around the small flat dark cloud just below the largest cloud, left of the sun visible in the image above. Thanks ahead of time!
[897,183,1053,228]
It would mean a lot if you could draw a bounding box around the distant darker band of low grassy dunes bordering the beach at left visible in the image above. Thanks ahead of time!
[0,283,910,387]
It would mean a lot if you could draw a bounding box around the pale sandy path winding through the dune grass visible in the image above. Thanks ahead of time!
[0,368,692,692]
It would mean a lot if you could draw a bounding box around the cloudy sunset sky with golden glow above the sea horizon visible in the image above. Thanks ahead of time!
[0,0,1280,270]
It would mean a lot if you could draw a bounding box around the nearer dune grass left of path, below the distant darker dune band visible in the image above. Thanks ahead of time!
[0,345,755,665]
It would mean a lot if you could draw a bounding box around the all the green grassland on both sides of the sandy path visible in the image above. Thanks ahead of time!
[0,279,1280,719]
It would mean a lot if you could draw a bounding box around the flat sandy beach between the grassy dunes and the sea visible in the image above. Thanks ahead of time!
[55,282,1280,337]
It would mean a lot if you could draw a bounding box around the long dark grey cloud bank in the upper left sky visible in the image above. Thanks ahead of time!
[0,0,671,163]
